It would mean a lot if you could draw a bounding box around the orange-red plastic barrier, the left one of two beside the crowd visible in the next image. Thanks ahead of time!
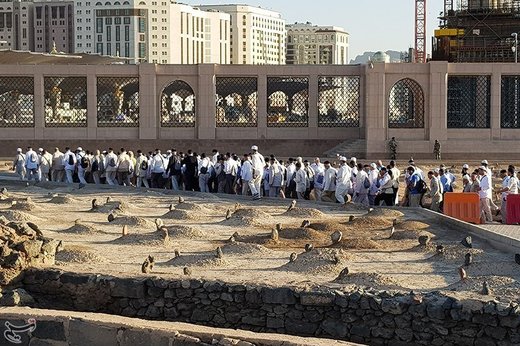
[443,192,480,224]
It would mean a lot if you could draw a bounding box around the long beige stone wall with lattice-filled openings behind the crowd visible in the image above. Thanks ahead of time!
[0,62,520,157]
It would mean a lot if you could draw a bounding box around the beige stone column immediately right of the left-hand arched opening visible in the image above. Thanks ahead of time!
[196,65,217,139]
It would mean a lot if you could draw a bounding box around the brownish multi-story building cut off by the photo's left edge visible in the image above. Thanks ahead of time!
[0,1,33,50]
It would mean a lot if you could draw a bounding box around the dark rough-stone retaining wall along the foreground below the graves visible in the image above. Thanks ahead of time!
[19,270,520,346]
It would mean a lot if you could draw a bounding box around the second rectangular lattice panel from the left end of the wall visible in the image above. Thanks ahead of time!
[44,77,87,127]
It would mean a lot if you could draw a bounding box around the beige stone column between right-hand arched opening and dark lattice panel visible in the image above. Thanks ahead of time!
[426,62,448,142]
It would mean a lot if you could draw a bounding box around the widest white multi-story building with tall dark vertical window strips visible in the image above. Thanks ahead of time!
[75,0,230,64]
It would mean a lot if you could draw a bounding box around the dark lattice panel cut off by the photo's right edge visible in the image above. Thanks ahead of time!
[500,76,520,129]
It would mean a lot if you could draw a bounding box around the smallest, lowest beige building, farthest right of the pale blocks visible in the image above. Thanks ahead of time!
[286,23,349,65]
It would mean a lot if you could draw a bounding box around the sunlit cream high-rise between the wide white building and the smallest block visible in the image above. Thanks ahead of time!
[200,5,285,65]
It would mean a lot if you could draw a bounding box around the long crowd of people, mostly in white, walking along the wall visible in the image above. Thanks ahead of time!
[13,145,519,222]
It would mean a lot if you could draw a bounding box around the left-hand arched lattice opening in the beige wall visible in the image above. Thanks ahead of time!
[161,80,196,127]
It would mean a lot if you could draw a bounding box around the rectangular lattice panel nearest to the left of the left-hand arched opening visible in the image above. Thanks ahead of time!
[97,77,139,127]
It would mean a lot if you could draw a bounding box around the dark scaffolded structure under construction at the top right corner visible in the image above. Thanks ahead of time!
[432,0,520,62]
